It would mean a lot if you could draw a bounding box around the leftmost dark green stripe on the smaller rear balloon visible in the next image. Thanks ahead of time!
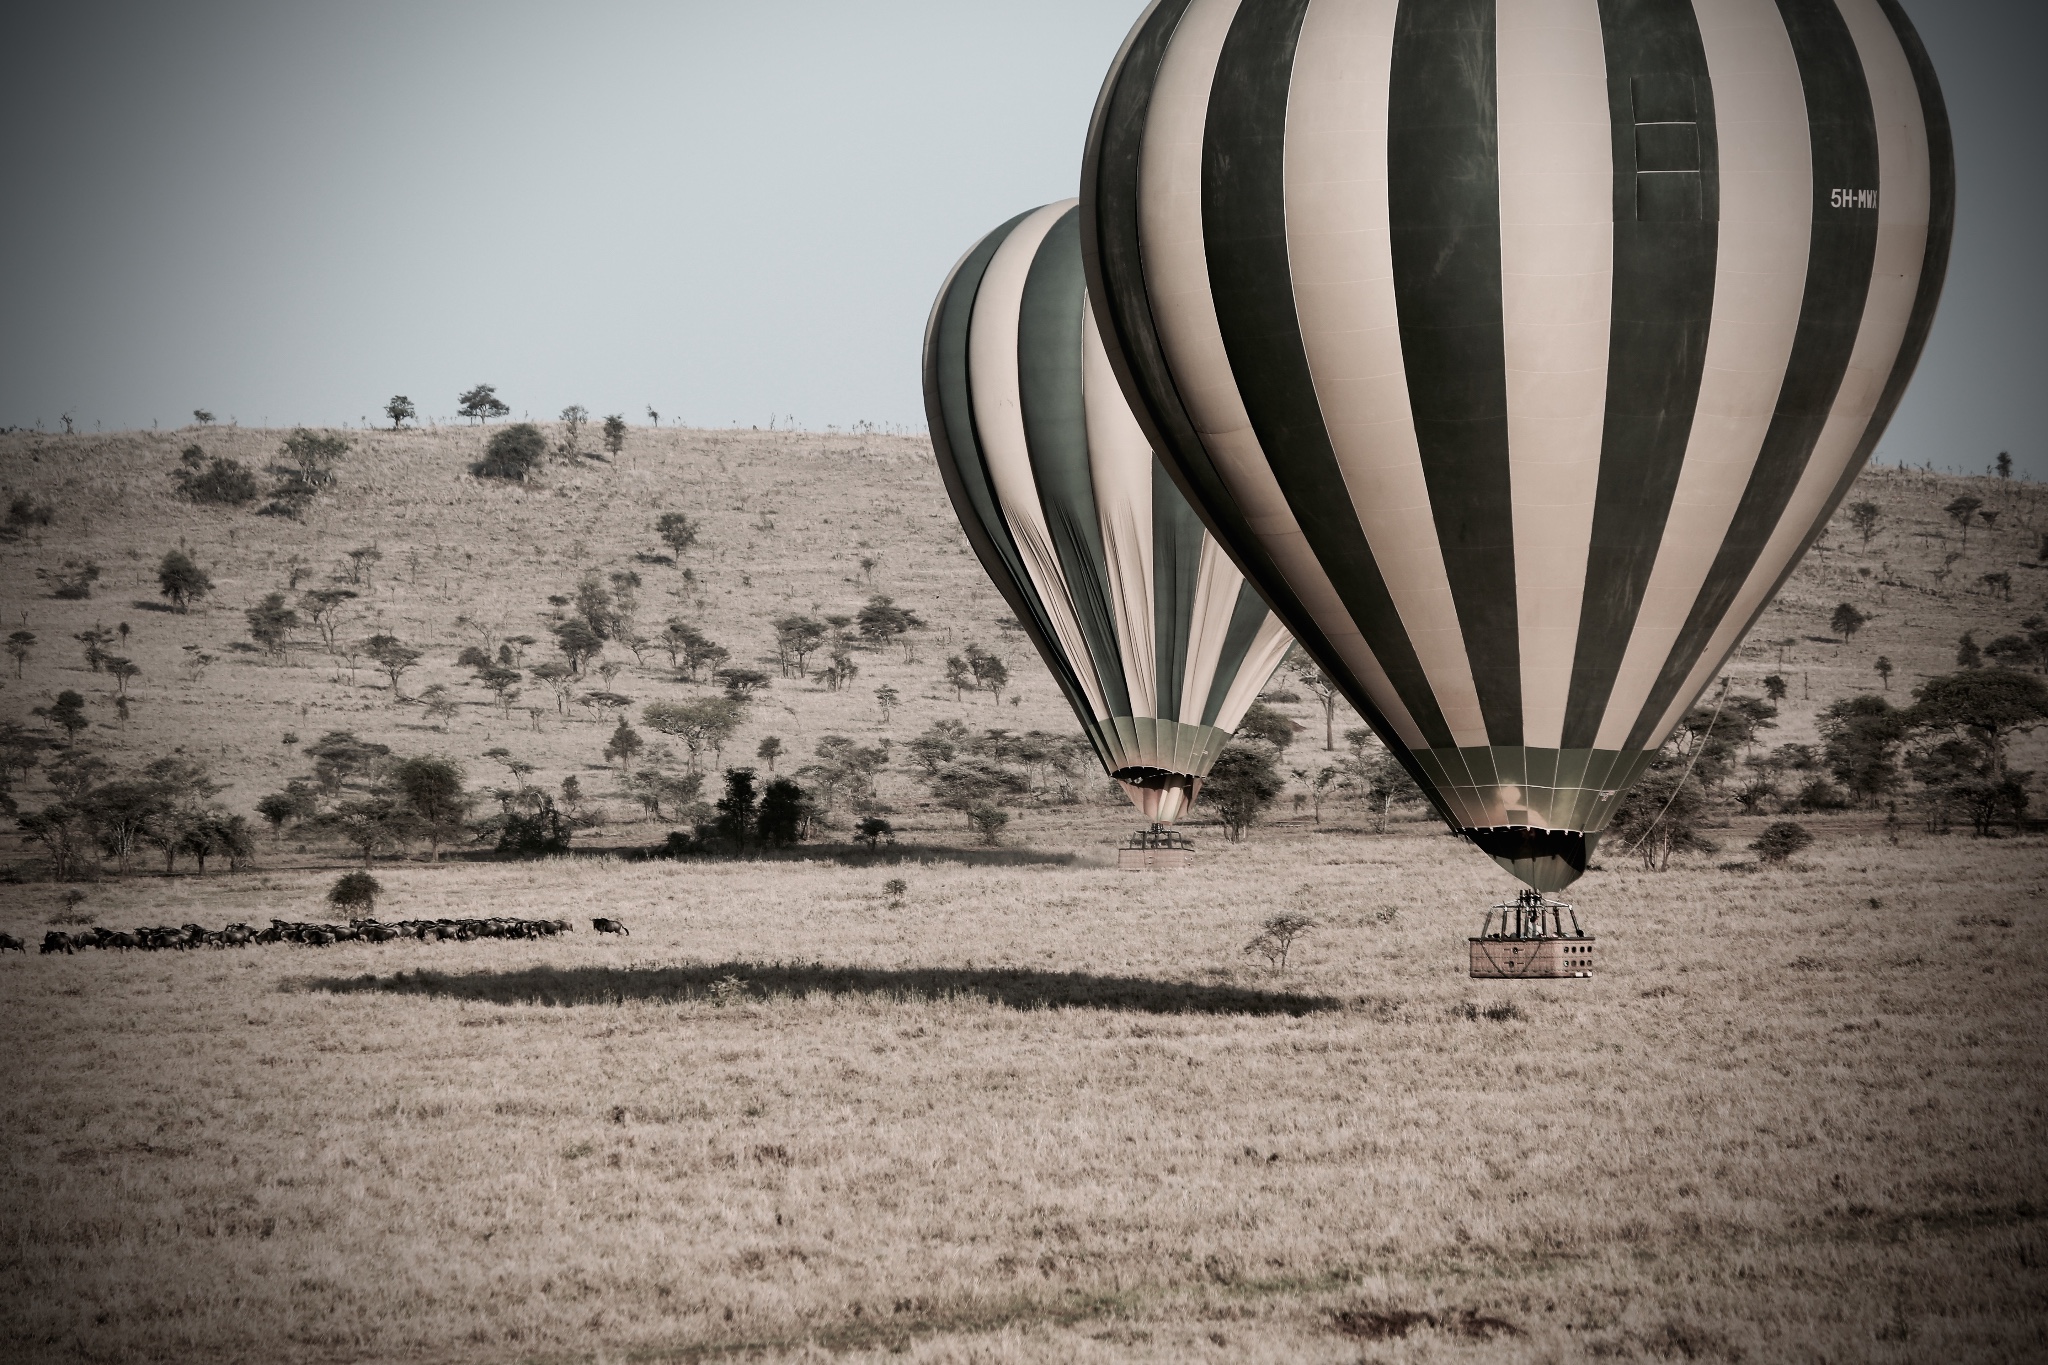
[924,213,1112,772]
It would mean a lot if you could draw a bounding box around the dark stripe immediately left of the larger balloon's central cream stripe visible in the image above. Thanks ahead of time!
[1392,0,1522,745]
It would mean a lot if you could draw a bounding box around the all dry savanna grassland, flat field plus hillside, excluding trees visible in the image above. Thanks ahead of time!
[0,430,2048,1363]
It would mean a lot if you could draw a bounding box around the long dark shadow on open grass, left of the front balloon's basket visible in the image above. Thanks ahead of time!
[296,962,1343,1015]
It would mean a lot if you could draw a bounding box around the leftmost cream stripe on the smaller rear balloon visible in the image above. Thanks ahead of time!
[967,203,1110,718]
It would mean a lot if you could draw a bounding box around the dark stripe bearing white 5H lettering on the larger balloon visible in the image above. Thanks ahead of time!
[1626,0,1878,749]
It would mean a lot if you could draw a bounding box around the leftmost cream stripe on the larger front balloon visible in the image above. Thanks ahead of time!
[1139,0,1423,747]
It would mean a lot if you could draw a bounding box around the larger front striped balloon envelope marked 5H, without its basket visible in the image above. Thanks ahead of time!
[1081,0,1954,890]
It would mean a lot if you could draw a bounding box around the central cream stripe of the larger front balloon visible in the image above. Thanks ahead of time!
[1495,0,1614,749]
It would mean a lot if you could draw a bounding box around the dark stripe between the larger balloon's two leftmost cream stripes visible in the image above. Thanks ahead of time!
[1202,0,1458,745]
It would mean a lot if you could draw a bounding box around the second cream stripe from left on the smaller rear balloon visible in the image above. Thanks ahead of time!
[1081,284,1161,716]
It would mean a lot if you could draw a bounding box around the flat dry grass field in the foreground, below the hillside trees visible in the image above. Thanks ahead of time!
[0,833,2048,1363]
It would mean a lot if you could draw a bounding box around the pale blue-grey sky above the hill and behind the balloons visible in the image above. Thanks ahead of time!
[0,0,2048,479]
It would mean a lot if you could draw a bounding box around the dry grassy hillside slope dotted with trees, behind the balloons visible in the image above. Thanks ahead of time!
[0,428,2048,857]
